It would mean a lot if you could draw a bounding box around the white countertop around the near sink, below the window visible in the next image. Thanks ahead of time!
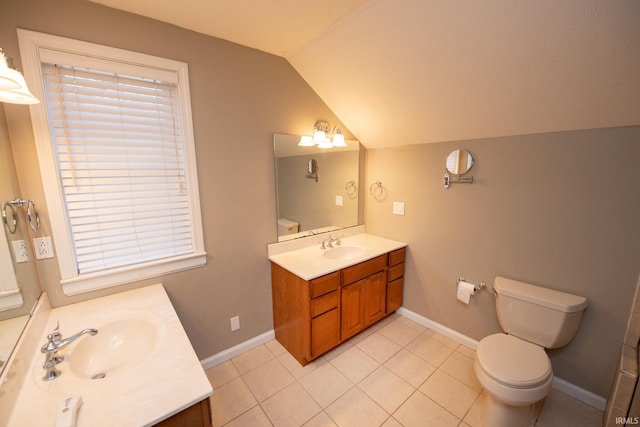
[9,284,212,427]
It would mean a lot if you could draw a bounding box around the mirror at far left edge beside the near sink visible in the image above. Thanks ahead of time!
[0,112,41,373]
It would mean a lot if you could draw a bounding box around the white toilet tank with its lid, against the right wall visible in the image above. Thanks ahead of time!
[493,277,587,348]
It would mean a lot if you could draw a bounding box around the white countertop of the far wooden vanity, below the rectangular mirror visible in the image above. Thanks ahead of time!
[269,233,407,280]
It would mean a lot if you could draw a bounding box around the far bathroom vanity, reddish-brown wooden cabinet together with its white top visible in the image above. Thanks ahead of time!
[269,234,406,365]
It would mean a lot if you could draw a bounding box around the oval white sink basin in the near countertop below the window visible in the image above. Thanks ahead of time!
[66,318,158,379]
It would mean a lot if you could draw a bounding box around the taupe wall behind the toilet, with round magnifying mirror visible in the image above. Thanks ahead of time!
[365,127,640,396]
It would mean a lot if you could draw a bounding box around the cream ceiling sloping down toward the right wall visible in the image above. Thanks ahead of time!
[87,0,640,147]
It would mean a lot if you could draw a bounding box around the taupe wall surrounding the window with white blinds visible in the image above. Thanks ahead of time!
[0,0,352,358]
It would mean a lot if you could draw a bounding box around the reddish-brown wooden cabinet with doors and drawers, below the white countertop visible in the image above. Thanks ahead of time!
[271,248,405,365]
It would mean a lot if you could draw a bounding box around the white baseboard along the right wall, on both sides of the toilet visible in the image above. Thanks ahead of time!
[397,307,607,411]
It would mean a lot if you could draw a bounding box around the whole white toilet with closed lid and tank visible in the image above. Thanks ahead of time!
[474,277,587,427]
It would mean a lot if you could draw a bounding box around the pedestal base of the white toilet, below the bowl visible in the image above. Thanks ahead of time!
[481,393,544,427]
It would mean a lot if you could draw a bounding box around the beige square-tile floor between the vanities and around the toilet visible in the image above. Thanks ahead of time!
[207,314,602,427]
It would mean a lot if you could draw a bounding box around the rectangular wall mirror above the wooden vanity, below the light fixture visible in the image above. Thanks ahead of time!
[273,133,364,242]
